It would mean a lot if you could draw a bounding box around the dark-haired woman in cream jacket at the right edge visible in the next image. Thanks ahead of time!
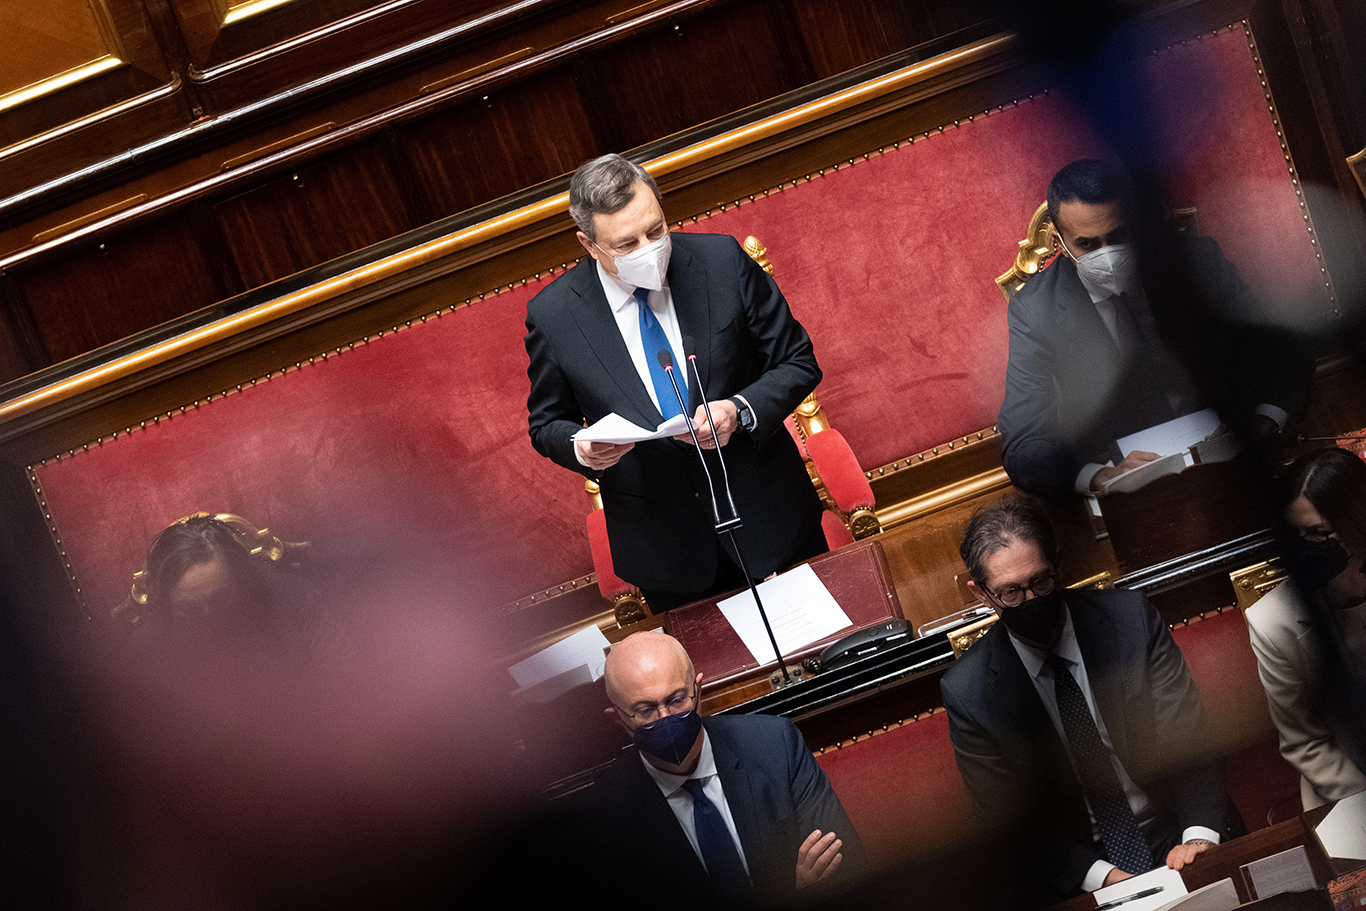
[1246,449,1366,810]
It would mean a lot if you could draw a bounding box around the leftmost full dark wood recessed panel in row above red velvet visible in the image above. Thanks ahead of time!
[18,214,224,361]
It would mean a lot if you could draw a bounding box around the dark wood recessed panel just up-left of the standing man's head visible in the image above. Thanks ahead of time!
[399,68,602,220]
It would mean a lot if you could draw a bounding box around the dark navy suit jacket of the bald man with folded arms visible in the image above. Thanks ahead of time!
[583,714,866,907]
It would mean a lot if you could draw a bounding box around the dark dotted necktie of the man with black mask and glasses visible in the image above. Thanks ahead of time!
[1048,654,1154,873]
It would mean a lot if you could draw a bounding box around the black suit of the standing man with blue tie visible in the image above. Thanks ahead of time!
[526,234,821,593]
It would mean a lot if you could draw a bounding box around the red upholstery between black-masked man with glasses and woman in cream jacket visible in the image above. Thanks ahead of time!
[1172,608,1299,830]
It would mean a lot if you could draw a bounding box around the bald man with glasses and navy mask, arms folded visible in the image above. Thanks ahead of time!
[583,632,865,907]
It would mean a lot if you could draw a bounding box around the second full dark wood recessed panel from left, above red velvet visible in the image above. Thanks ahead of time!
[213,141,417,288]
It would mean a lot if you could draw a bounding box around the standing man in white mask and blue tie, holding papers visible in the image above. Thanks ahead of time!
[526,154,826,609]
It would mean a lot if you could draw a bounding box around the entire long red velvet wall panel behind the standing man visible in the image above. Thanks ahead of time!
[29,29,1324,609]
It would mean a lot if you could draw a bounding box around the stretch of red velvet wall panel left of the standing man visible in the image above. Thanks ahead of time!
[36,275,576,612]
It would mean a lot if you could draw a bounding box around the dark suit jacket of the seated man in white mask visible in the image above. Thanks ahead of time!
[997,238,1313,496]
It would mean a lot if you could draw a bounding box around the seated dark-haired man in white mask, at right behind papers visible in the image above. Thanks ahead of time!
[997,160,1313,496]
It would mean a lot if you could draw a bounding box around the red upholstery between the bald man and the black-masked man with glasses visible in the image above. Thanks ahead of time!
[817,710,978,867]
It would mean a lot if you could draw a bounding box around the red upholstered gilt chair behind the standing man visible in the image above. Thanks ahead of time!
[583,236,882,627]
